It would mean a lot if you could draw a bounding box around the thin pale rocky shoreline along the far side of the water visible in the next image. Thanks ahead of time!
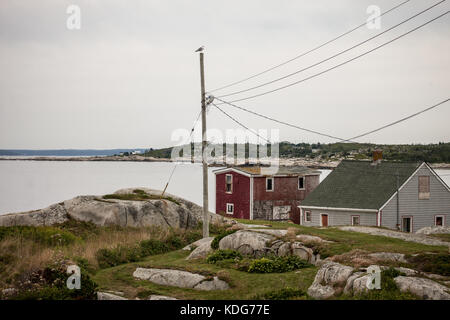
[0,155,450,169]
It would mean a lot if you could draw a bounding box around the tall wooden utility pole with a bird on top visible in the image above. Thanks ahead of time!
[199,49,209,238]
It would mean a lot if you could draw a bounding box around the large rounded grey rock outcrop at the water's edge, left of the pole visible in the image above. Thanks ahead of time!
[0,188,226,229]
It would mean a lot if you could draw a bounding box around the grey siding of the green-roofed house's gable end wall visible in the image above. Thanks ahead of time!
[381,165,450,232]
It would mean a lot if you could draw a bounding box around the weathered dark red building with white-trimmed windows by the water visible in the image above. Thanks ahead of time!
[214,166,320,223]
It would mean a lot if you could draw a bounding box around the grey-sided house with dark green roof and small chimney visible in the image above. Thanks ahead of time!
[299,154,450,232]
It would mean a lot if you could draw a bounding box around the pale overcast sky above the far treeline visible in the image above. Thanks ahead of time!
[0,0,450,149]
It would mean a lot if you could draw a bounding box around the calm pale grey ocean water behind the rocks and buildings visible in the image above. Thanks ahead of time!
[0,160,450,214]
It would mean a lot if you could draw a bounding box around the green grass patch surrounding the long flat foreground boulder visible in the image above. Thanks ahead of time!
[94,250,317,300]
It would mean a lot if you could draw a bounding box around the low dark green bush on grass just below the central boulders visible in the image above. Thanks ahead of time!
[247,256,310,273]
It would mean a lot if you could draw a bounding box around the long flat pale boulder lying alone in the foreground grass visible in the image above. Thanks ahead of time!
[133,268,229,290]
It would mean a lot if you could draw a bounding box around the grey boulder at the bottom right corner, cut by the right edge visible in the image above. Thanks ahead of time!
[394,276,450,300]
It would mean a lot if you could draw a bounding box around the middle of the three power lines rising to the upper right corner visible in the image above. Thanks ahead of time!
[218,0,446,98]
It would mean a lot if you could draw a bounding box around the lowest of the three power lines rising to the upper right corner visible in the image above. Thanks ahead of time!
[216,11,449,102]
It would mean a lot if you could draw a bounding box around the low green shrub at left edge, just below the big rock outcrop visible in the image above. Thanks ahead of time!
[0,226,79,246]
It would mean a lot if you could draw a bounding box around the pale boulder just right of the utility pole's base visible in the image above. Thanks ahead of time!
[219,230,276,257]
